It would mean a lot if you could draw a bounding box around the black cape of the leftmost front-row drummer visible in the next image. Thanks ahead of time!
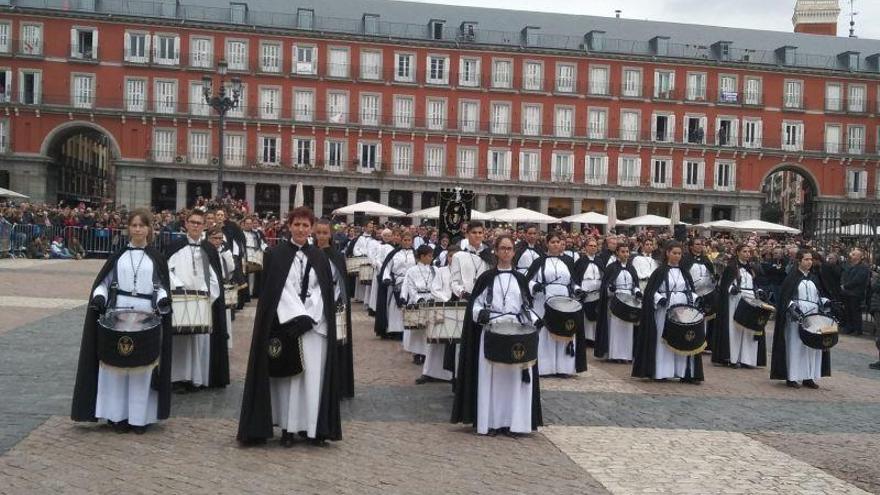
[70,246,173,421]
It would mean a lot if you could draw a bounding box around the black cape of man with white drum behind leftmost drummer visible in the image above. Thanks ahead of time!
[167,236,229,388]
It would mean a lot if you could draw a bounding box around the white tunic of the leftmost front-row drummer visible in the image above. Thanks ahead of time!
[92,249,168,426]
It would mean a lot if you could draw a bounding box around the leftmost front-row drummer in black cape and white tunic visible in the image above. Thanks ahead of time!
[70,210,172,434]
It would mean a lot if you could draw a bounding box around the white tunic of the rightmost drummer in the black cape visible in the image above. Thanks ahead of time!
[779,279,828,382]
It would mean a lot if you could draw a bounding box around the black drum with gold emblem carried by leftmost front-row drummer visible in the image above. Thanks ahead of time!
[97,309,162,368]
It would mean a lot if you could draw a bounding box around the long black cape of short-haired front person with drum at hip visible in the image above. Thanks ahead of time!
[236,242,342,443]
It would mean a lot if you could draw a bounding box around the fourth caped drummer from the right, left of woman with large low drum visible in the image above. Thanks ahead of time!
[593,243,642,363]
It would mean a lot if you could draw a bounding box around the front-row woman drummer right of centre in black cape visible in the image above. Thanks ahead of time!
[452,235,543,435]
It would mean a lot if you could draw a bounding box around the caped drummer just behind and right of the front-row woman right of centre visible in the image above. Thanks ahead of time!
[526,232,587,377]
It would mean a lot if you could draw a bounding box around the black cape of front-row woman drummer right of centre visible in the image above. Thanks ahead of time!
[450,268,544,430]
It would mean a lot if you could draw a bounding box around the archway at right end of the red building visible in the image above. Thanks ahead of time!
[761,165,819,235]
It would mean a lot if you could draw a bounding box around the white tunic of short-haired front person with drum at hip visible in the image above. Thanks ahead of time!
[269,246,327,438]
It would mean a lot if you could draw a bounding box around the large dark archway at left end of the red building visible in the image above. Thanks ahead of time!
[46,125,115,204]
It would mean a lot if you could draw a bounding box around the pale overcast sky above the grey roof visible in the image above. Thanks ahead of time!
[404,0,880,39]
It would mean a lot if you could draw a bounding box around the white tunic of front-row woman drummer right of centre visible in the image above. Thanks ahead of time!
[474,270,532,435]
